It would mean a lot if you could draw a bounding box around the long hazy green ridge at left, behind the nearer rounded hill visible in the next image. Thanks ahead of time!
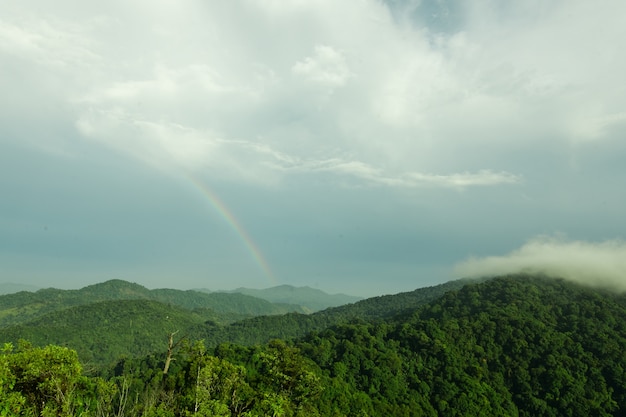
[0,280,305,327]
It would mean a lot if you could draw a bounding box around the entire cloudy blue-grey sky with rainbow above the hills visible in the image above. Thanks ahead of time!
[0,0,626,296]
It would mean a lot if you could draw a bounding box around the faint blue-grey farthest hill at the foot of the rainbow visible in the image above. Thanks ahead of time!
[224,285,363,312]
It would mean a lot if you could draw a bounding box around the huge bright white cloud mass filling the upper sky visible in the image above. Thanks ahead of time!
[0,0,626,186]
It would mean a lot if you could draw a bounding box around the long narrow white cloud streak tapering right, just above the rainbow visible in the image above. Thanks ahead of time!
[76,104,522,189]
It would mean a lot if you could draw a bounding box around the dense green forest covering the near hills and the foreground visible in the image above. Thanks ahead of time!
[0,274,626,417]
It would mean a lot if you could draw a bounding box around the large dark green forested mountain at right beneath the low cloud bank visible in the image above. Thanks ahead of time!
[297,275,626,417]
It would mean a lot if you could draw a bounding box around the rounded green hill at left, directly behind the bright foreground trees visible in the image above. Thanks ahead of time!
[0,300,208,366]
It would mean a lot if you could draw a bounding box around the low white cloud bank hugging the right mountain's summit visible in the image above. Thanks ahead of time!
[456,237,626,291]
